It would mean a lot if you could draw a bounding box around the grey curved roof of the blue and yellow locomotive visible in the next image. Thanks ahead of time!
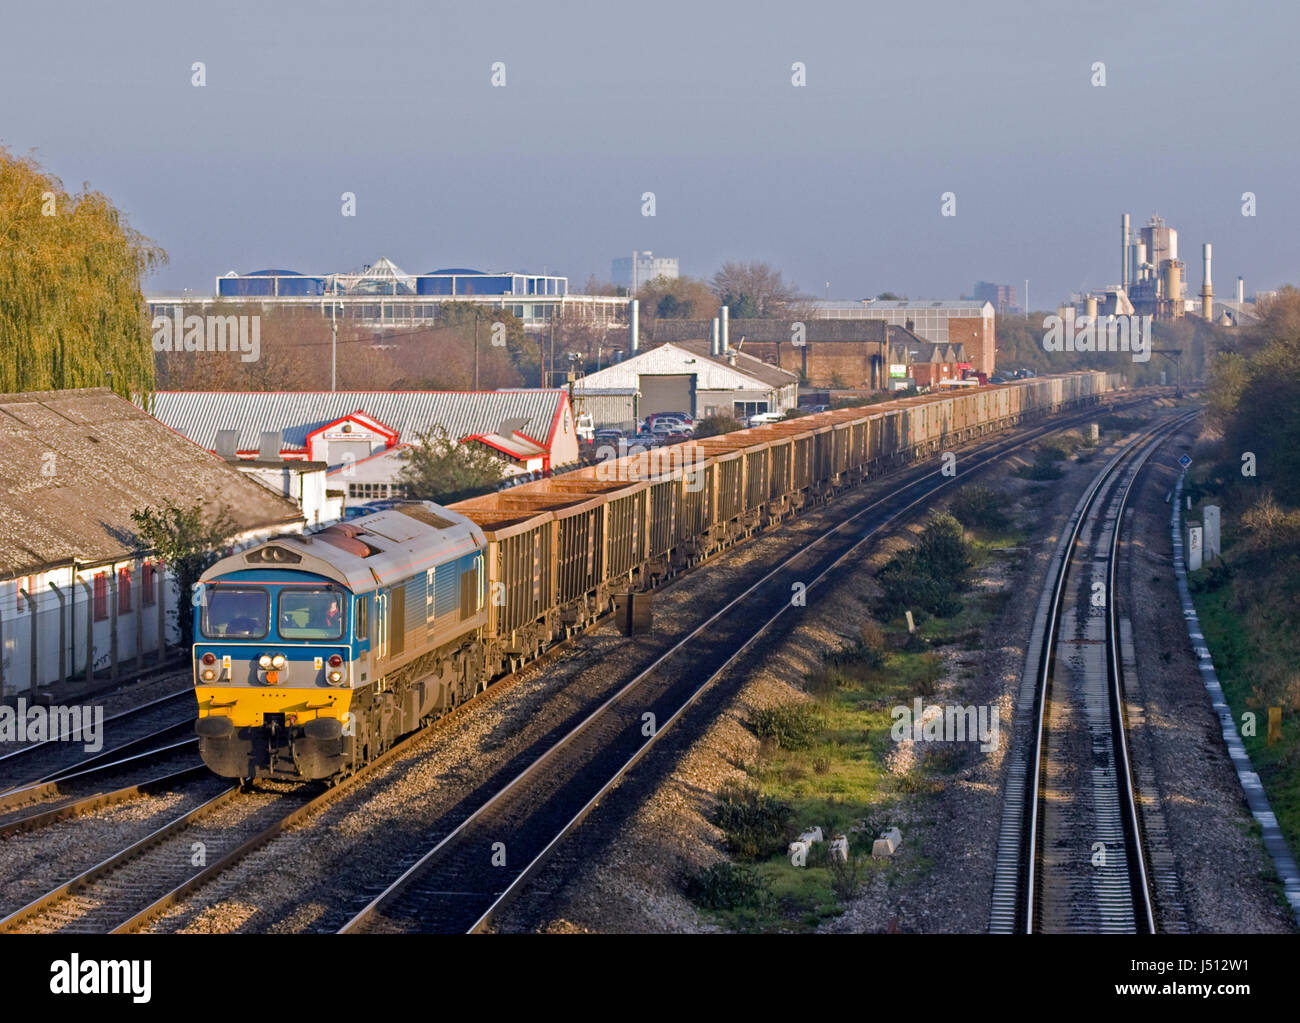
[203,500,485,591]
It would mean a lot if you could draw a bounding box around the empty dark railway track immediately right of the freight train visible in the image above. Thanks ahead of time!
[341,400,1149,933]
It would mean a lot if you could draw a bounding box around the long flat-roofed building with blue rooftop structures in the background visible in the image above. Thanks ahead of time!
[146,259,628,333]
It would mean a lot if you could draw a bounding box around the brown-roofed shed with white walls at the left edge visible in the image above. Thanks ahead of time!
[0,387,303,699]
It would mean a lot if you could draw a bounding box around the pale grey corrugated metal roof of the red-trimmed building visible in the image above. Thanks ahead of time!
[152,387,567,451]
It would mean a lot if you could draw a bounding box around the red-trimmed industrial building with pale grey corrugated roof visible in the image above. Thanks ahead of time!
[150,387,579,503]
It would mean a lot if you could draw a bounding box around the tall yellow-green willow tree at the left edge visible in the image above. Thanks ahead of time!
[0,147,166,396]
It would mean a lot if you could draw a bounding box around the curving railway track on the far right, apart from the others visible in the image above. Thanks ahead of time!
[991,413,1196,933]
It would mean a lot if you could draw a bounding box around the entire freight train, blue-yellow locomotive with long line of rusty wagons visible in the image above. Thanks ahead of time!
[194,372,1117,780]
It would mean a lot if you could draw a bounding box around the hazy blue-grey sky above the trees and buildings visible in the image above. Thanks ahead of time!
[0,0,1300,308]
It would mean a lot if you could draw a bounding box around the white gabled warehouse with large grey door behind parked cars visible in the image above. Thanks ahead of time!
[573,341,798,429]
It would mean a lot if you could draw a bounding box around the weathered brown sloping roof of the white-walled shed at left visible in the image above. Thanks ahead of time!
[0,387,302,578]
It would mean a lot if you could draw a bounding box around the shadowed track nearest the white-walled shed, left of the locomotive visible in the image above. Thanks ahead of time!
[0,688,196,797]
